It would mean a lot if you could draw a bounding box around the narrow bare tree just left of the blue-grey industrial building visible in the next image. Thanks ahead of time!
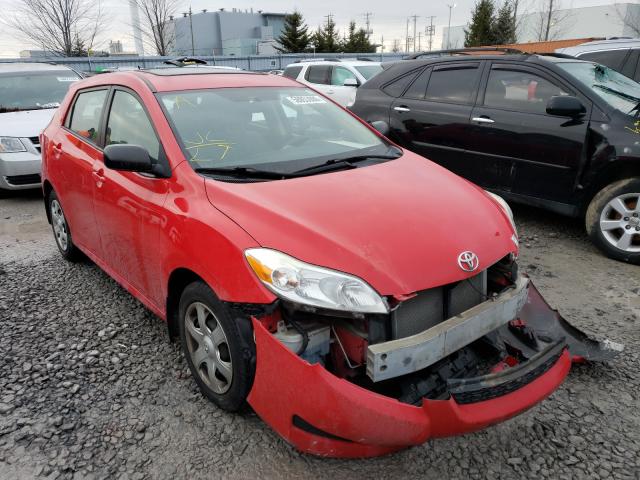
[134,0,180,56]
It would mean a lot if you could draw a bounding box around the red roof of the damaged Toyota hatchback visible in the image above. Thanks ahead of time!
[74,67,304,92]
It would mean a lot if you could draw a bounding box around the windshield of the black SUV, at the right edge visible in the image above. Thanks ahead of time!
[557,62,640,114]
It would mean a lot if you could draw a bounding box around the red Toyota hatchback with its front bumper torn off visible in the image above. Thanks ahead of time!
[41,67,616,457]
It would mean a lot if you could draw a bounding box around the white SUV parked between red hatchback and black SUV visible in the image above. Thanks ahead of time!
[282,59,382,107]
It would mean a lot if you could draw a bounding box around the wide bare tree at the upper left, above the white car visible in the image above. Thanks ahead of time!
[4,0,104,57]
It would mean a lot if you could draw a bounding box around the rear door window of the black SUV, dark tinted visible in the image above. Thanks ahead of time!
[425,63,479,103]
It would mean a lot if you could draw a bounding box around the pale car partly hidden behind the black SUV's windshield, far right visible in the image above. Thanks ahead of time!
[556,38,640,82]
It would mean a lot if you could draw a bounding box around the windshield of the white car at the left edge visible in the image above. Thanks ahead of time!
[0,70,80,113]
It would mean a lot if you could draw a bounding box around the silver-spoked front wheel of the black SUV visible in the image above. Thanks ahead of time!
[586,178,640,264]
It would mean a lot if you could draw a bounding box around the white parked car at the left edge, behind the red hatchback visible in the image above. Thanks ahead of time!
[0,63,80,191]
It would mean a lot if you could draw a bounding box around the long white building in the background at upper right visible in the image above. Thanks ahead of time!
[442,3,640,49]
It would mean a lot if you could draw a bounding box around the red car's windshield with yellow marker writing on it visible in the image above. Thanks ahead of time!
[158,87,389,171]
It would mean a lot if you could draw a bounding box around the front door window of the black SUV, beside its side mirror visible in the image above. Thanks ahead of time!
[484,68,568,113]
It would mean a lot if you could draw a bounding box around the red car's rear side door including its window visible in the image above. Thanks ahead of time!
[50,87,109,253]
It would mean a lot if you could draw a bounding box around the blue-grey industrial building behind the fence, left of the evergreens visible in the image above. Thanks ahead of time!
[173,8,285,56]
